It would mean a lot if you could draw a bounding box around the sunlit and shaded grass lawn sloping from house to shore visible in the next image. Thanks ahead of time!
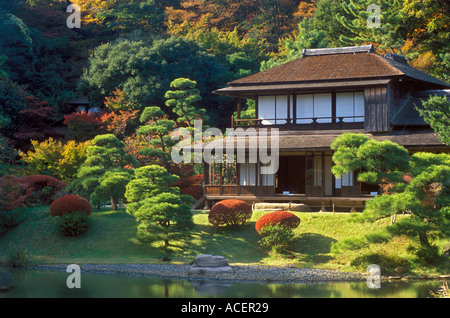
[0,207,448,274]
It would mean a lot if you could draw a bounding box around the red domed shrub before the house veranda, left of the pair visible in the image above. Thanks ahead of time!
[208,199,252,227]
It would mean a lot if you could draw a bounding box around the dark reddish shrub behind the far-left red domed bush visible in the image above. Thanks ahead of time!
[21,175,67,203]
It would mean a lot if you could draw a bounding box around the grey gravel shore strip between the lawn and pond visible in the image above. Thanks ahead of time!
[27,264,366,283]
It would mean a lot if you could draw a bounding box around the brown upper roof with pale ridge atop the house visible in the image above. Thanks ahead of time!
[224,46,450,89]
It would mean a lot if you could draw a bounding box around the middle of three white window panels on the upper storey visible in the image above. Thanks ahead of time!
[297,93,332,124]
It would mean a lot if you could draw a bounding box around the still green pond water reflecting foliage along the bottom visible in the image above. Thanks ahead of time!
[0,270,442,298]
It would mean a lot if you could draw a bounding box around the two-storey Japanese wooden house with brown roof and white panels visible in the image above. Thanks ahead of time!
[197,45,450,210]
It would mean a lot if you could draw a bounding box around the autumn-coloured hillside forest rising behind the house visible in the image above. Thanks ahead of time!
[0,0,450,176]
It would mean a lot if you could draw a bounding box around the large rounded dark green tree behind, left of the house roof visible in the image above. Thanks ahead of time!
[80,37,229,123]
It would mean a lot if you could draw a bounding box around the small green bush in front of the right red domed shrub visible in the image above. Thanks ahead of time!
[259,224,294,253]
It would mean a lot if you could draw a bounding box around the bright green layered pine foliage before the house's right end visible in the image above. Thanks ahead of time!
[332,134,450,262]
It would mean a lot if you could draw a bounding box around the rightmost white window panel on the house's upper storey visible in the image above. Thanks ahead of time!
[336,92,364,123]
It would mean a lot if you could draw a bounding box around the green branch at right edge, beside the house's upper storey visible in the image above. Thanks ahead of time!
[416,96,450,145]
